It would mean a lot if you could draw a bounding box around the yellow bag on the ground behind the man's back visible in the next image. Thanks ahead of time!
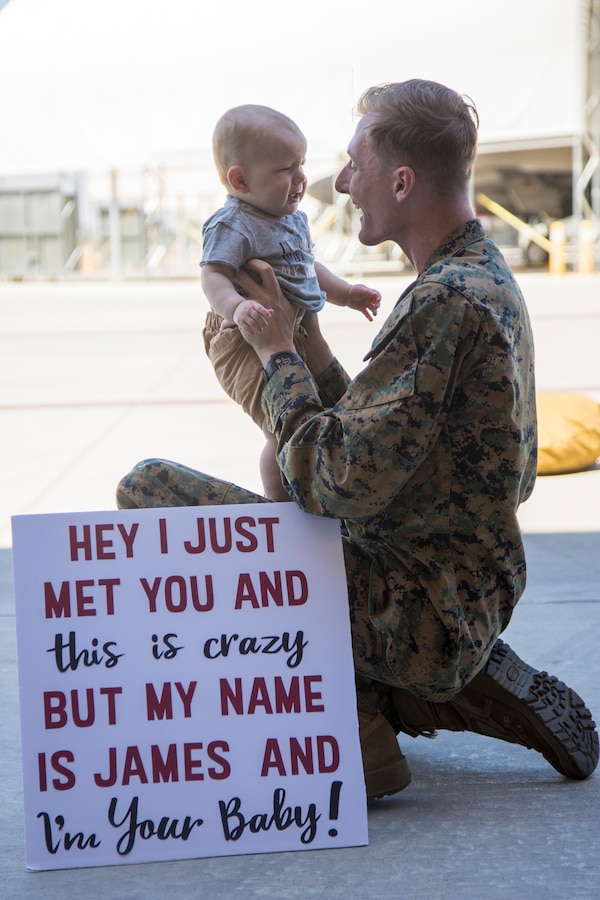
[536,391,600,475]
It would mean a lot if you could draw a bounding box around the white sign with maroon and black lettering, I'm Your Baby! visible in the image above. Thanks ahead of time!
[13,503,368,869]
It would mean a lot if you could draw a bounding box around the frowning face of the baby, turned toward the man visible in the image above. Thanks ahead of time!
[243,132,306,218]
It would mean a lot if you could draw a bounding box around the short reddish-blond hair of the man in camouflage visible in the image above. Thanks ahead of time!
[358,78,479,190]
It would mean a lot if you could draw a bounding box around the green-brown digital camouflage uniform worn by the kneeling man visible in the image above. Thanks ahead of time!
[119,220,536,701]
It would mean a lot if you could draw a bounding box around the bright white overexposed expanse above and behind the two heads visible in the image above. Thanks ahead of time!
[0,0,582,183]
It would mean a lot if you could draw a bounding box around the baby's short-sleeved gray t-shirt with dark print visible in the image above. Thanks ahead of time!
[200,197,326,312]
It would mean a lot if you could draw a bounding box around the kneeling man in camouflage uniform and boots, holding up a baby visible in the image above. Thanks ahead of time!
[118,80,598,798]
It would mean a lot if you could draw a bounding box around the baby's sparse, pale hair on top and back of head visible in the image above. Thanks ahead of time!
[213,103,306,184]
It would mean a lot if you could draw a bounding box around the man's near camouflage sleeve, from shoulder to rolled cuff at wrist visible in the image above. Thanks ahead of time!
[263,289,477,519]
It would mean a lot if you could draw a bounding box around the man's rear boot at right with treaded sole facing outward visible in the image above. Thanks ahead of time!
[391,640,599,778]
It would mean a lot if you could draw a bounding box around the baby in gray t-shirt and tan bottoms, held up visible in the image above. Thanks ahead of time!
[200,105,381,501]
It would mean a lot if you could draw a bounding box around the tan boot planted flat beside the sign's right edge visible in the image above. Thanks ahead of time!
[358,692,410,800]
